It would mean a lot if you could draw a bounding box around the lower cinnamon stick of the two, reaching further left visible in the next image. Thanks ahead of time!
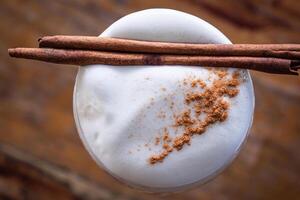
[8,48,300,75]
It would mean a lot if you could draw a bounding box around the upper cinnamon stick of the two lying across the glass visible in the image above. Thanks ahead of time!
[39,35,300,60]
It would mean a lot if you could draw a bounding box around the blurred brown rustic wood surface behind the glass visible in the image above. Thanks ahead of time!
[0,0,300,200]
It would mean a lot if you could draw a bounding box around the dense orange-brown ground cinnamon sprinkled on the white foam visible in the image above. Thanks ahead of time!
[149,70,240,164]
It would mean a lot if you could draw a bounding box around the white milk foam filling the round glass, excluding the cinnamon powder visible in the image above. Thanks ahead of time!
[74,9,254,191]
